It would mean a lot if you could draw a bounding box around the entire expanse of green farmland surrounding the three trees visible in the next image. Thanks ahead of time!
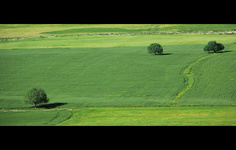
[0,24,236,125]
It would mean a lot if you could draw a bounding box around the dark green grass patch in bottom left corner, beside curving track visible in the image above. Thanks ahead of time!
[0,110,71,126]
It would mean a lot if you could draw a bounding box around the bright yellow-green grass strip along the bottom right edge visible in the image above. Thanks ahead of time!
[58,107,236,126]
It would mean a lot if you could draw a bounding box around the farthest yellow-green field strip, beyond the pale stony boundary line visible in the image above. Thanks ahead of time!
[0,24,236,38]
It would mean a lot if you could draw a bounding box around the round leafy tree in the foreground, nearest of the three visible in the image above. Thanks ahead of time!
[23,88,49,109]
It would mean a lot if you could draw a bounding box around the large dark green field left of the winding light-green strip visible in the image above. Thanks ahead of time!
[0,46,194,108]
